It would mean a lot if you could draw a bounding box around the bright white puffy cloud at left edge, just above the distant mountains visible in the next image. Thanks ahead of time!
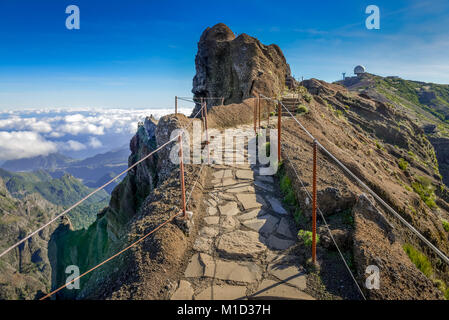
[0,131,57,160]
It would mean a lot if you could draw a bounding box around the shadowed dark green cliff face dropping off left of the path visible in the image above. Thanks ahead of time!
[52,115,199,298]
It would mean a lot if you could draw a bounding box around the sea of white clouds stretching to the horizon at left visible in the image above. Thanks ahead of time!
[0,108,191,161]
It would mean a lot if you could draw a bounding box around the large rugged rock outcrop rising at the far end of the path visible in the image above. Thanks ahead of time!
[192,23,292,113]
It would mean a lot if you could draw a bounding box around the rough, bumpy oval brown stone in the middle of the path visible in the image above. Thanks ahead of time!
[217,230,267,258]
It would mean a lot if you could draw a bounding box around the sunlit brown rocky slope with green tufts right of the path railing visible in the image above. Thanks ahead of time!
[282,79,449,299]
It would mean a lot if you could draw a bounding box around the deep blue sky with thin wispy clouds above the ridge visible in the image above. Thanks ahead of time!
[0,0,449,109]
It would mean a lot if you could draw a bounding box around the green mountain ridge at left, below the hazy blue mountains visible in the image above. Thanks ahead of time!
[0,169,110,229]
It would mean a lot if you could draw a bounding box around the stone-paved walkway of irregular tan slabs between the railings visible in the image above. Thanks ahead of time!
[171,126,313,300]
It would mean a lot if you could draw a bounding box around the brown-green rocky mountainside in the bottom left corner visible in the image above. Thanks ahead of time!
[0,178,58,300]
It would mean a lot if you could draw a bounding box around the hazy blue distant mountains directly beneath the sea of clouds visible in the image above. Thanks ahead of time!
[2,147,130,193]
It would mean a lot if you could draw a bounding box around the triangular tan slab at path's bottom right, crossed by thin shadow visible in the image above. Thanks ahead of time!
[249,279,315,300]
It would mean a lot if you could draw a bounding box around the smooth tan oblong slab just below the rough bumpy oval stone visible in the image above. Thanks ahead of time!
[215,260,262,283]
